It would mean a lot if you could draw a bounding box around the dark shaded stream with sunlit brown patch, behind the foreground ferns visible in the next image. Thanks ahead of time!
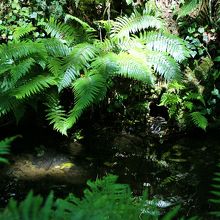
[0,124,220,219]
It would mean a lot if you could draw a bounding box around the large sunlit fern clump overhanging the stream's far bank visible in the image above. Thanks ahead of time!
[0,5,188,134]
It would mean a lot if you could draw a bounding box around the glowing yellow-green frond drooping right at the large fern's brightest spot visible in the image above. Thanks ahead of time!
[116,51,154,85]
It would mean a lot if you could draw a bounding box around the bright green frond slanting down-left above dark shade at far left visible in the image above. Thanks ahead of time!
[12,75,56,99]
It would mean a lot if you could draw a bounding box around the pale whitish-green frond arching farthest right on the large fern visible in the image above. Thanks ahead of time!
[140,31,189,62]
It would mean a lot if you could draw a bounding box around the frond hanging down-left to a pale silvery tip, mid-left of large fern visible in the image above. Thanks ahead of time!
[58,43,98,91]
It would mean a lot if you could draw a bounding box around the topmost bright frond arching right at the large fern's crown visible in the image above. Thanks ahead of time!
[111,11,163,38]
